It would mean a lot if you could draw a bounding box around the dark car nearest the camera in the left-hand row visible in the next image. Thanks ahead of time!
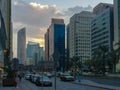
[35,76,52,86]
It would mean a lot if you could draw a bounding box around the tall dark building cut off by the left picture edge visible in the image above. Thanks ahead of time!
[0,0,12,66]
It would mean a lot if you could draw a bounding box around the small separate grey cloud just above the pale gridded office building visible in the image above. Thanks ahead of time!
[64,5,92,16]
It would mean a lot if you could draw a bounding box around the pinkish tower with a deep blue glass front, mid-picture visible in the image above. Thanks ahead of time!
[48,19,65,71]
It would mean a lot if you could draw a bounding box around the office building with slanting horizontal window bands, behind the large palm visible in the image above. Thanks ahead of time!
[91,3,114,56]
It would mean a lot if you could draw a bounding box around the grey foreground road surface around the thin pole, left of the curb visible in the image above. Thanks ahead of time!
[0,78,103,90]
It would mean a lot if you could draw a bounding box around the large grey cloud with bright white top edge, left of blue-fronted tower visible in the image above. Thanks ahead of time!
[12,0,64,38]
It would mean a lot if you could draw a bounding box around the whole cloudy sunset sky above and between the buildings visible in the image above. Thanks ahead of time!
[12,0,113,57]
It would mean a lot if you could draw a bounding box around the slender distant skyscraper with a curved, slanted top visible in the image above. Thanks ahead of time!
[17,28,26,64]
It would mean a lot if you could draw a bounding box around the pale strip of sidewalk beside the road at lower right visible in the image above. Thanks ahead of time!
[73,80,120,90]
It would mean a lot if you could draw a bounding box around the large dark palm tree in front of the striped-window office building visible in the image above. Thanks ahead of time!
[93,45,109,75]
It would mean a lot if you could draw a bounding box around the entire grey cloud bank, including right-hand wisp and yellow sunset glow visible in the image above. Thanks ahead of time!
[12,0,92,56]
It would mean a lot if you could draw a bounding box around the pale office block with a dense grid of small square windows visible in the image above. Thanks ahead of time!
[67,11,94,61]
